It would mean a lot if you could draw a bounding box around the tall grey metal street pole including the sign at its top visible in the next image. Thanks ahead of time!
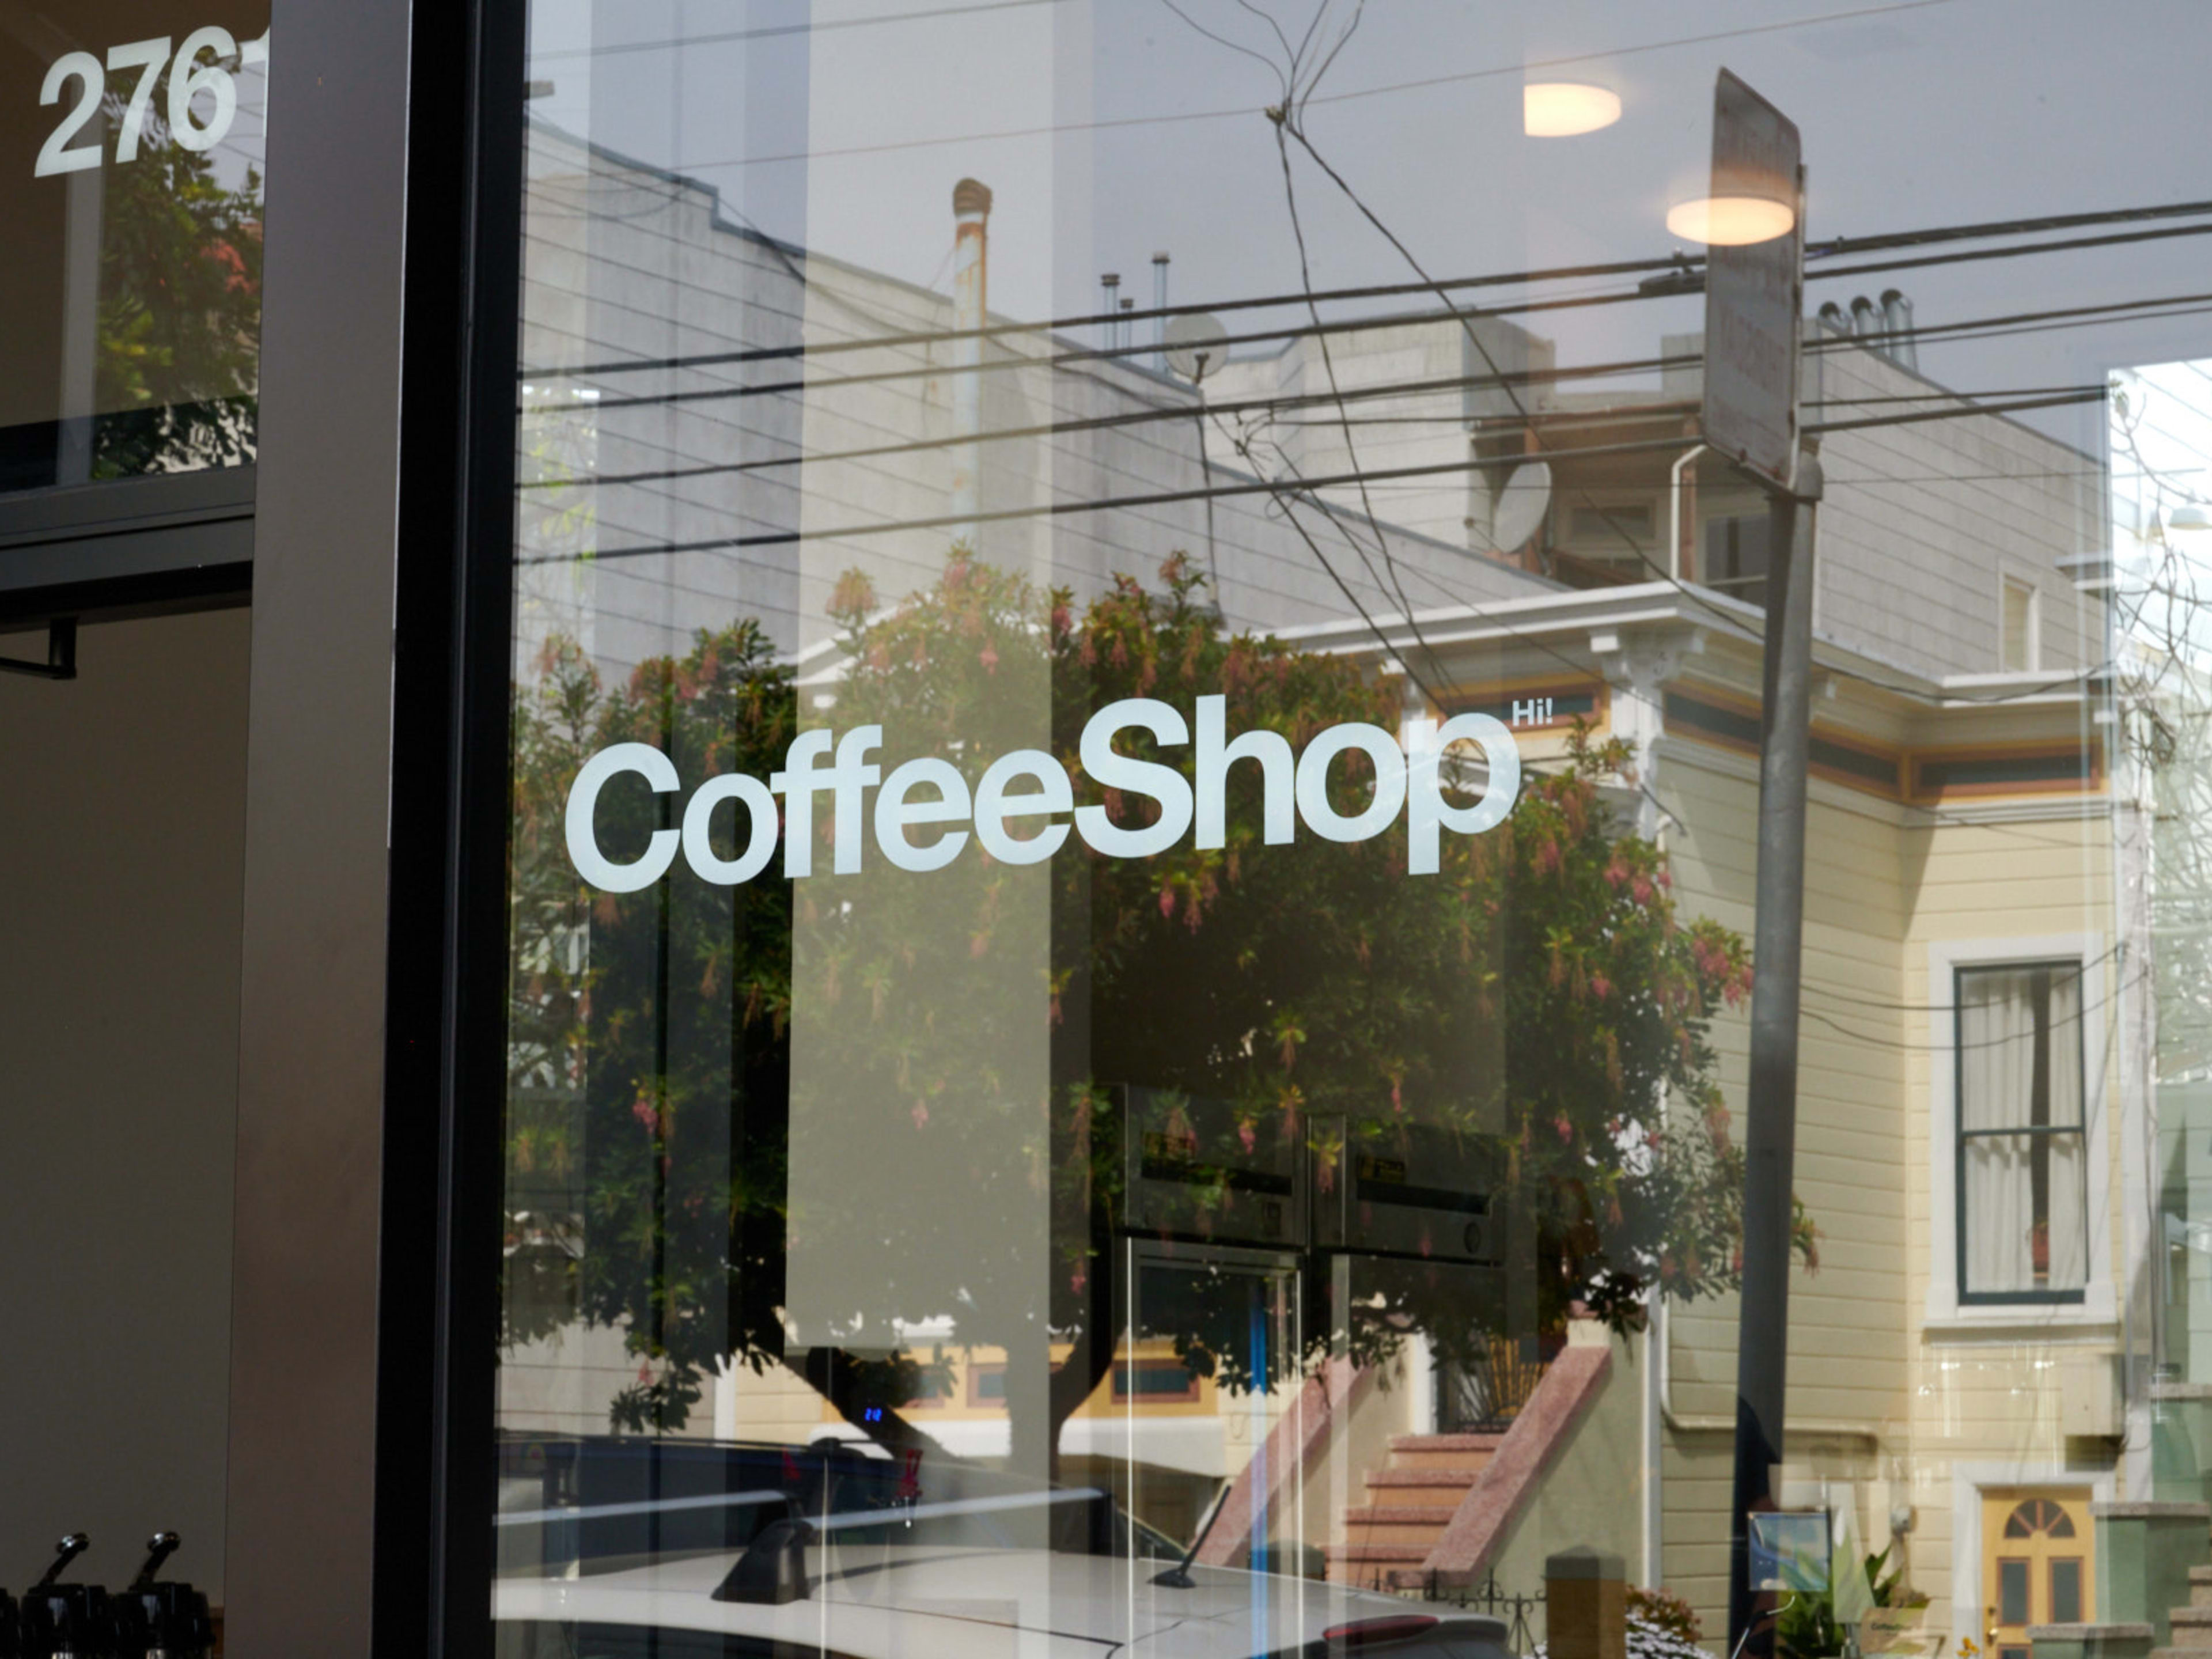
[1703,69,1820,1659]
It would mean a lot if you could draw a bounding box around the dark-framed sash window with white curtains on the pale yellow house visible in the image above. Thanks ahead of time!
[1956,962,2088,1303]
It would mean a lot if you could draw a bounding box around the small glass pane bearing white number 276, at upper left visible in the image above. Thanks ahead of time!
[0,0,270,491]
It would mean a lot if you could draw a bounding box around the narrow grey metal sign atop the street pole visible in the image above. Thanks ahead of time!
[1706,69,1805,489]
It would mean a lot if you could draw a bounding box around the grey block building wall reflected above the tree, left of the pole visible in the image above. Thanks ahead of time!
[518,126,1546,685]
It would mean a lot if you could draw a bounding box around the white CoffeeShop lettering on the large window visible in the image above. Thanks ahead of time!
[566,697,1520,893]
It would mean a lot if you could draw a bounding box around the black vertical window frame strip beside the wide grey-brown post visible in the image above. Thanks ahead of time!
[385,0,527,1659]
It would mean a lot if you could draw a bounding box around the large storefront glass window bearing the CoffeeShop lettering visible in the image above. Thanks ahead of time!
[491,0,2212,1659]
